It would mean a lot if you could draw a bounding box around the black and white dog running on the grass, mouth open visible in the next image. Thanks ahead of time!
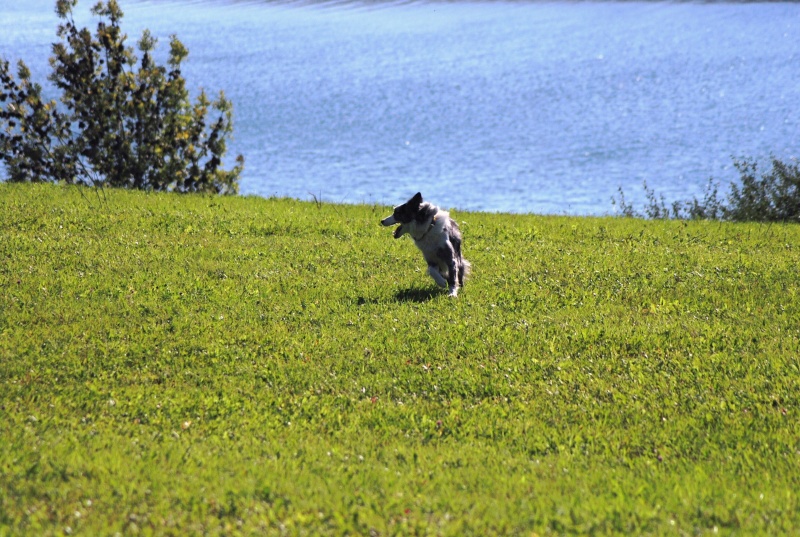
[381,192,470,296]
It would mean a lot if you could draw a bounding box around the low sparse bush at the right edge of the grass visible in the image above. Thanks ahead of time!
[612,157,800,222]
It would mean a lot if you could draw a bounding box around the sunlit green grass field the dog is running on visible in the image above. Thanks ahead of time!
[0,184,800,536]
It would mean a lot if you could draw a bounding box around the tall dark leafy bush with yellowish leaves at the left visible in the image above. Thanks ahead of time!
[0,0,244,194]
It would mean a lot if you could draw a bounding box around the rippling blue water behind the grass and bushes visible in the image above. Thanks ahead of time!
[0,0,800,215]
